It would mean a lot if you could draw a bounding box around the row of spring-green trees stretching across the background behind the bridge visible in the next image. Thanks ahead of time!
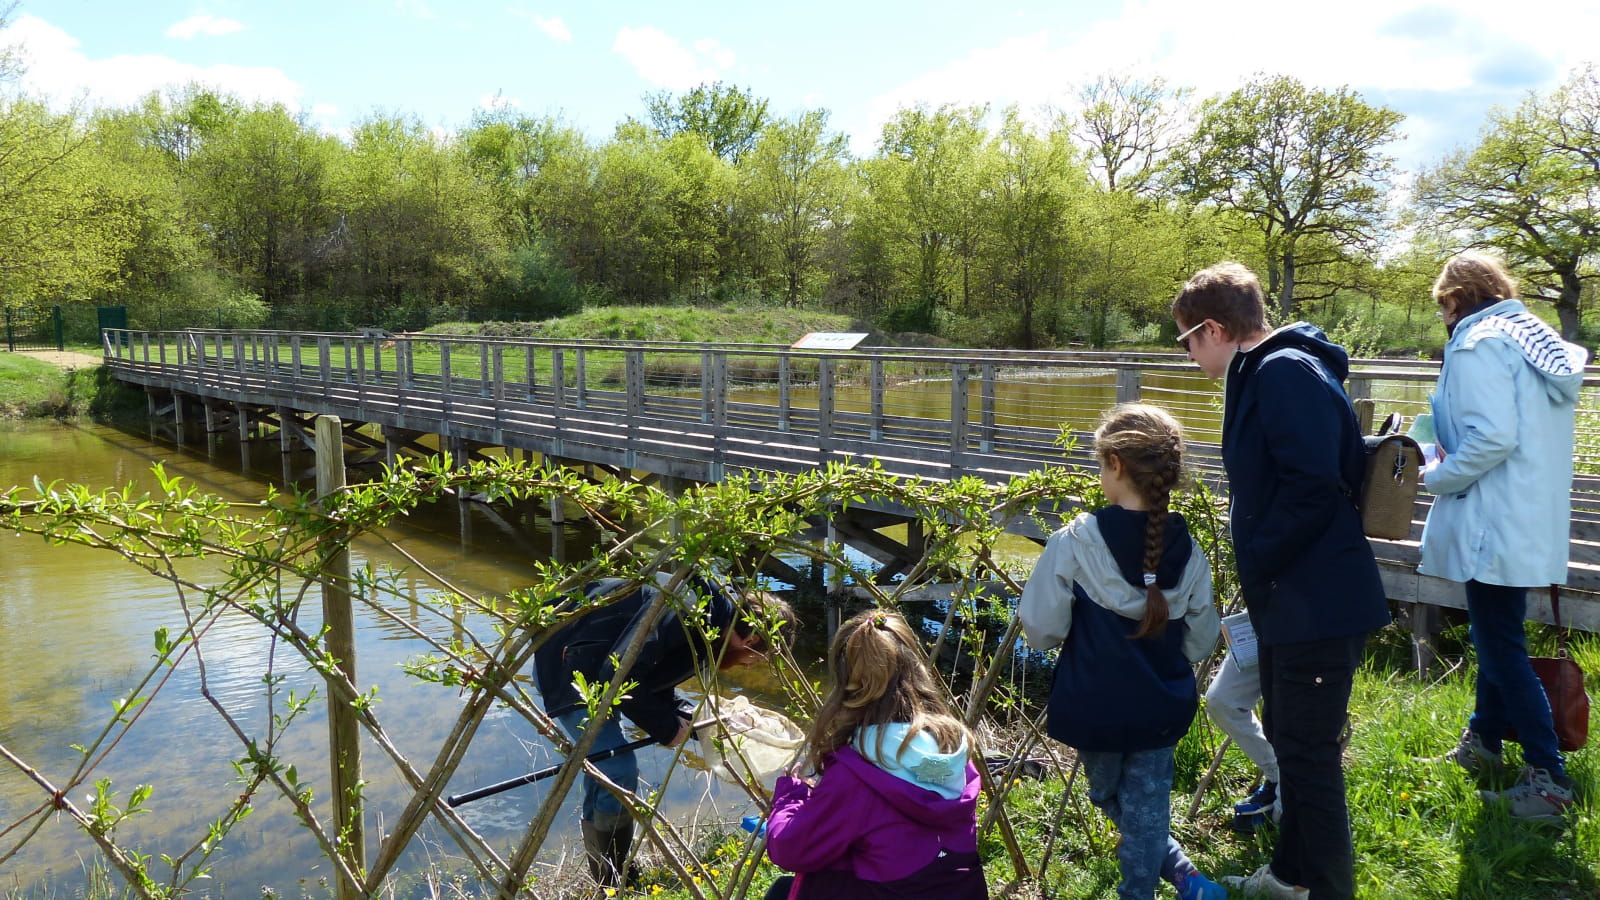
[0,30,1600,348]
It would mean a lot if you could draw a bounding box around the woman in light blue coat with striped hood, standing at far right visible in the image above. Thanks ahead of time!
[1419,251,1589,820]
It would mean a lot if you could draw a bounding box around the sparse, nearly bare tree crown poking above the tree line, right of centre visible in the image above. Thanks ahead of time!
[1074,75,1190,194]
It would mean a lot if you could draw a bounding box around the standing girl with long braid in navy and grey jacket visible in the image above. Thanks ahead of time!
[1018,404,1227,900]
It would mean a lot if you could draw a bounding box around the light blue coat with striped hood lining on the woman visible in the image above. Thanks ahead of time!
[1418,299,1589,588]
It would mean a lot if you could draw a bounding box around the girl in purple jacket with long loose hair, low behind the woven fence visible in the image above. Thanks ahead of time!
[766,610,989,900]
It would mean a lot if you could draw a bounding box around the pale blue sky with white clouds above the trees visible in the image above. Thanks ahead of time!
[0,0,1600,170]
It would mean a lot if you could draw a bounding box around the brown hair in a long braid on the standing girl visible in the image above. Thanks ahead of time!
[1094,404,1184,637]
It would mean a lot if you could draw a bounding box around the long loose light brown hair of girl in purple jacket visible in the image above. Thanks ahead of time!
[806,610,966,772]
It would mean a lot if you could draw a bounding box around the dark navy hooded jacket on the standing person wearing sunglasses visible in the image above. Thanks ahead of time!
[1222,322,1389,645]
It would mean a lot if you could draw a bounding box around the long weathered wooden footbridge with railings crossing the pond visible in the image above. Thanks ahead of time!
[104,330,1600,631]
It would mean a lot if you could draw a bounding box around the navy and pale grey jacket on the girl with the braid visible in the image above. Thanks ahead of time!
[1018,506,1219,753]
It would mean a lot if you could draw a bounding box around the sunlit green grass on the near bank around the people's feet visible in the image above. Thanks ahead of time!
[630,614,1600,900]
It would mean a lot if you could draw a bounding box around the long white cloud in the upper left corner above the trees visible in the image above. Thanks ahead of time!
[0,14,302,109]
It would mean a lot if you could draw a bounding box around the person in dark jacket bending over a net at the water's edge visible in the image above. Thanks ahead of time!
[533,578,794,887]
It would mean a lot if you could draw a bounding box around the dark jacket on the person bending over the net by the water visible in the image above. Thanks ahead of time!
[533,578,734,743]
